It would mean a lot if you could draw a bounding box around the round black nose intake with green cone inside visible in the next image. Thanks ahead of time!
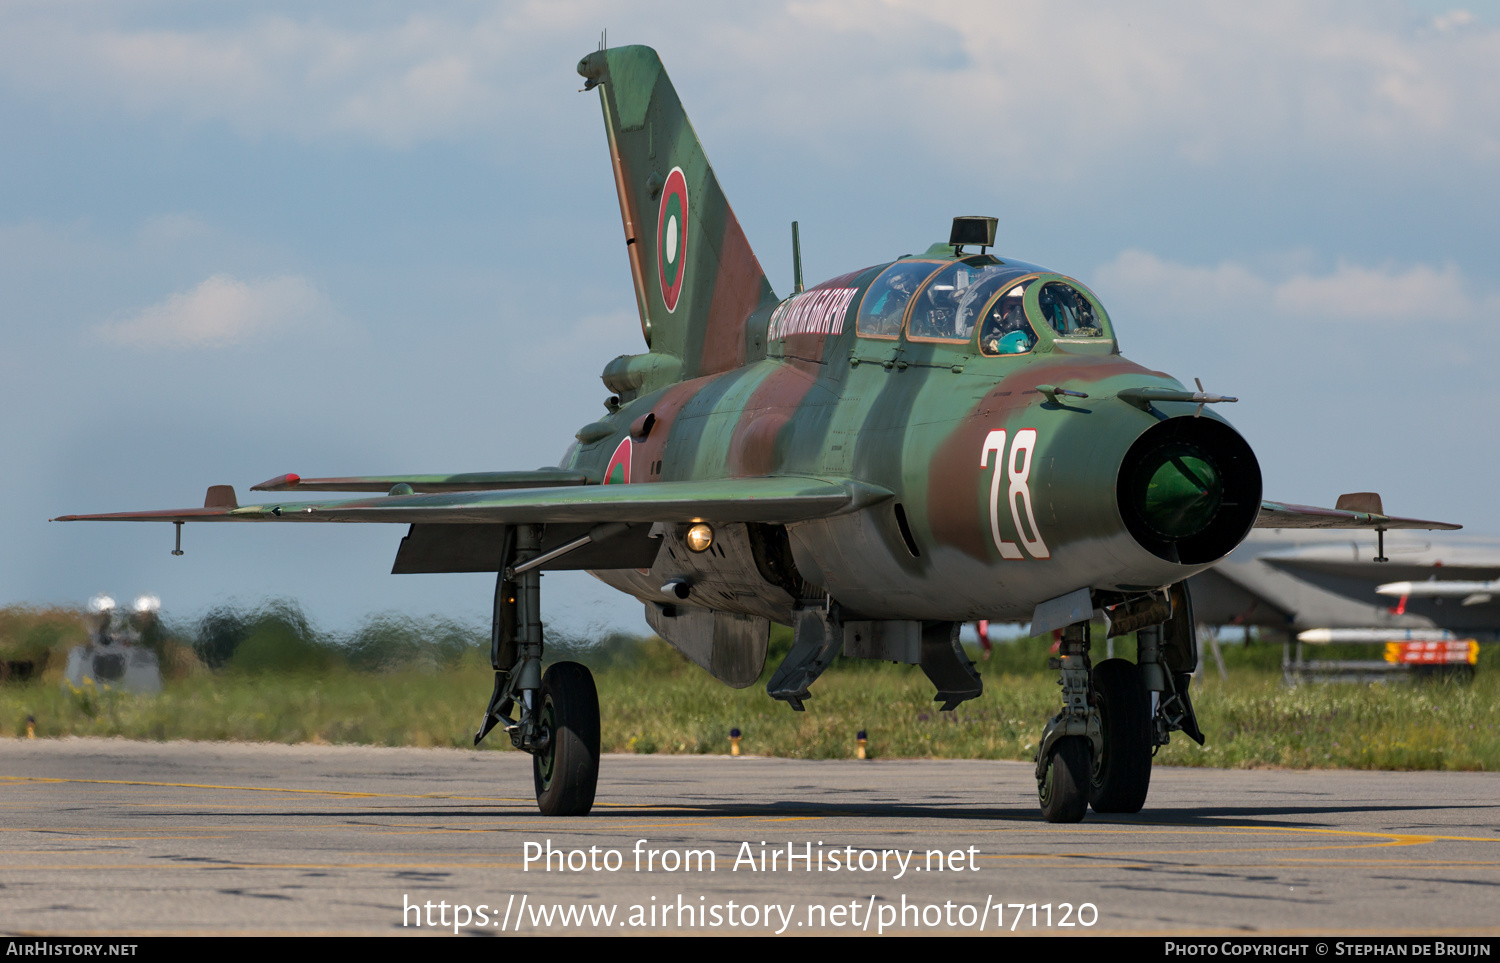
[1116,417,1260,566]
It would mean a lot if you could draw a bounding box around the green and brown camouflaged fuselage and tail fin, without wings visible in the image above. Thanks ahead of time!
[564,47,1452,623]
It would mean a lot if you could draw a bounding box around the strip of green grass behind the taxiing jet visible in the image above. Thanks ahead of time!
[0,609,1500,771]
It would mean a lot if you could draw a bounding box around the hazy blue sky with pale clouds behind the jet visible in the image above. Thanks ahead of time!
[0,0,1500,636]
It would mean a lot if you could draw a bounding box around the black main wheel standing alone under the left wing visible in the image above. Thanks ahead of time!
[531,662,599,816]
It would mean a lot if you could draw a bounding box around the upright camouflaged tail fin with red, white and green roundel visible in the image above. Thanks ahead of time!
[578,47,777,378]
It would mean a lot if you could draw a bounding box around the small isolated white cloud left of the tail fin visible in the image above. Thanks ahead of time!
[93,275,333,348]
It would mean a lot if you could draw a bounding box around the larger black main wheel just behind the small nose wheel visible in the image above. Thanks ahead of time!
[1089,659,1152,813]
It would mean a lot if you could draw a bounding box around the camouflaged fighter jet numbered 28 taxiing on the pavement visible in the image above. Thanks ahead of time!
[52,47,1457,822]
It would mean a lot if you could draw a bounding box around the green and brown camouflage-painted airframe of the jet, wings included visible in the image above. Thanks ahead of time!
[55,47,1454,663]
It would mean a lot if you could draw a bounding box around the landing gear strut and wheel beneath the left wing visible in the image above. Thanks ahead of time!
[474,525,599,816]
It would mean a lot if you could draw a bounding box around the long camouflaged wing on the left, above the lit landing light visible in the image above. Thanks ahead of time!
[54,476,891,525]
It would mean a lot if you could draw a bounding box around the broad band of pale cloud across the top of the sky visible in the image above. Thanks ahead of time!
[0,0,1500,168]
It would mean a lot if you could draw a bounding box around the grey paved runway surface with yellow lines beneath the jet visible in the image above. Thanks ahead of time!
[0,740,1500,936]
